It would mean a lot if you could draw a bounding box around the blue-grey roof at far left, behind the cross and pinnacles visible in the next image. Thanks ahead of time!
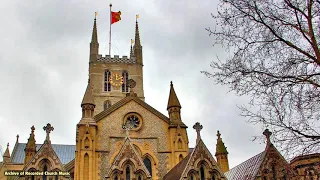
[11,143,76,164]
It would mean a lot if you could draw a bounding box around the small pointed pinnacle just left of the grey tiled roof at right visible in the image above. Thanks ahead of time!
[215,131,229,173]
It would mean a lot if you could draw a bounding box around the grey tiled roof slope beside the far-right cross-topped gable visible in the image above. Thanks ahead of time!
[225,152,265,180]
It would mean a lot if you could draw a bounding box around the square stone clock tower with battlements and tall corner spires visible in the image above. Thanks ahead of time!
[89,19,144,115]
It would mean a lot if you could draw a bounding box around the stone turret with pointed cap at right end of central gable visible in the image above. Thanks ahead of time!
[167,81,189,166]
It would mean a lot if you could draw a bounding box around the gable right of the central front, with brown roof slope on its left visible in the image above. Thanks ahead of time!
[163,139,224,180]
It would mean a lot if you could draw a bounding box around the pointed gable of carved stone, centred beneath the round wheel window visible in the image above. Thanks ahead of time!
[107,137,151,177]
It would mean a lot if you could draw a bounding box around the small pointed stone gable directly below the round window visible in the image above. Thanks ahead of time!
[107,137,151,177]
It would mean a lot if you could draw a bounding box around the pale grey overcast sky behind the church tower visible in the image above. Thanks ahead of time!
[0,0,265,167]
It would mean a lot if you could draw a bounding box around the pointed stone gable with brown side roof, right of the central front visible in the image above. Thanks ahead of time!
[163,139,225,180]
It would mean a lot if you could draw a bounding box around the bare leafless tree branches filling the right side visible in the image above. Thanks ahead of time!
[202,0,320,158]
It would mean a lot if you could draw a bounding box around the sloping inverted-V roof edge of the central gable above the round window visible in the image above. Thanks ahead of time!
[94,96,169,123]
